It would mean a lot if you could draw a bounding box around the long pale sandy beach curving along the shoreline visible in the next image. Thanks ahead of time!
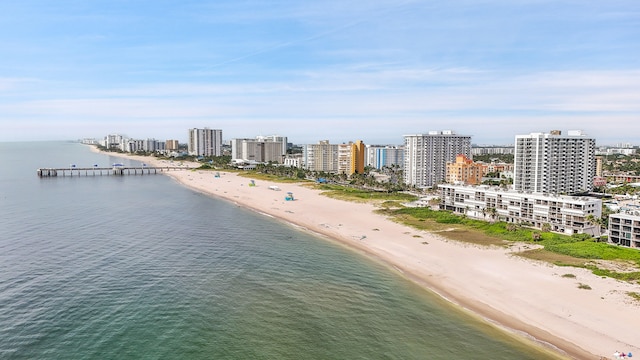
[97,151,640,359]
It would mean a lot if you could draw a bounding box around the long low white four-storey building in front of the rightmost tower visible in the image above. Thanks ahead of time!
[438,184,602,235]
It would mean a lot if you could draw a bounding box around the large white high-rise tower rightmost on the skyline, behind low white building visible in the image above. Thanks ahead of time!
[513,130,596,194]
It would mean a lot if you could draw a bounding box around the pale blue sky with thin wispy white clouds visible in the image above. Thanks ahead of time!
[0,0,640,145]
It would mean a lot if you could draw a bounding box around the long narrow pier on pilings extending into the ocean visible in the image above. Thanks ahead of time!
[37,166,193,177]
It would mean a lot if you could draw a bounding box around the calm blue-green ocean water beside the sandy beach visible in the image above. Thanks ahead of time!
[0,142,560,360]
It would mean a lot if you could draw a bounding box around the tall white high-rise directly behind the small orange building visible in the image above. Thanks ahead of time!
[404,130,471,188]
